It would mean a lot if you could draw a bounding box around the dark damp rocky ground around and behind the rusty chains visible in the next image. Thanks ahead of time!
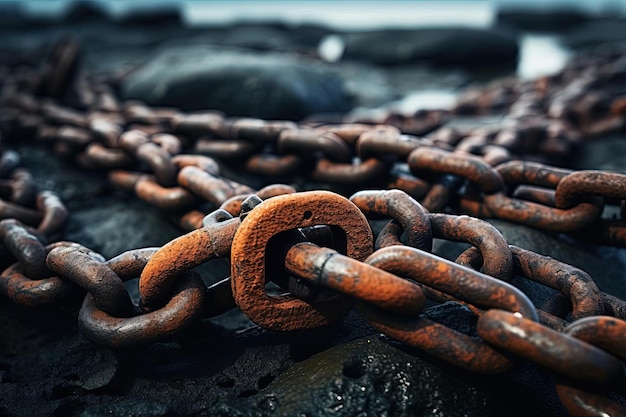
[0,3,626,417]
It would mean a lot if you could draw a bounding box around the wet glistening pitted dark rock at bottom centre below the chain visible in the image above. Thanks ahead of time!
[216,337,563,417]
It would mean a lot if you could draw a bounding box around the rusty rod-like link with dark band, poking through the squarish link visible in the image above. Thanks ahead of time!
[285,242,425,315]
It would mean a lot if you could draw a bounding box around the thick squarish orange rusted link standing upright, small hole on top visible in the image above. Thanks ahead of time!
[231,191,372,331]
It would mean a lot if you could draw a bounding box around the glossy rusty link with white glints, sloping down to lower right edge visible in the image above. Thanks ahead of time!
[477,309,624,385]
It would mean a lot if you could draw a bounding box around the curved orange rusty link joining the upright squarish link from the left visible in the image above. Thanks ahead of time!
[139,213,240,311]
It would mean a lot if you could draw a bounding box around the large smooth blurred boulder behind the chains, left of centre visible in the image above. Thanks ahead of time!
[122,47,351,120]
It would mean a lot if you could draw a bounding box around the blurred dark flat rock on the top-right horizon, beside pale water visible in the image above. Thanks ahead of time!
[496,7,591,32]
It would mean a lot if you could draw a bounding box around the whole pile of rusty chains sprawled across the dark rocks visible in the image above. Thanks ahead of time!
[0,38,626,415]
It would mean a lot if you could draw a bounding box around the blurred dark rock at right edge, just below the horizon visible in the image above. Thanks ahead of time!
[562,18,626,48]
